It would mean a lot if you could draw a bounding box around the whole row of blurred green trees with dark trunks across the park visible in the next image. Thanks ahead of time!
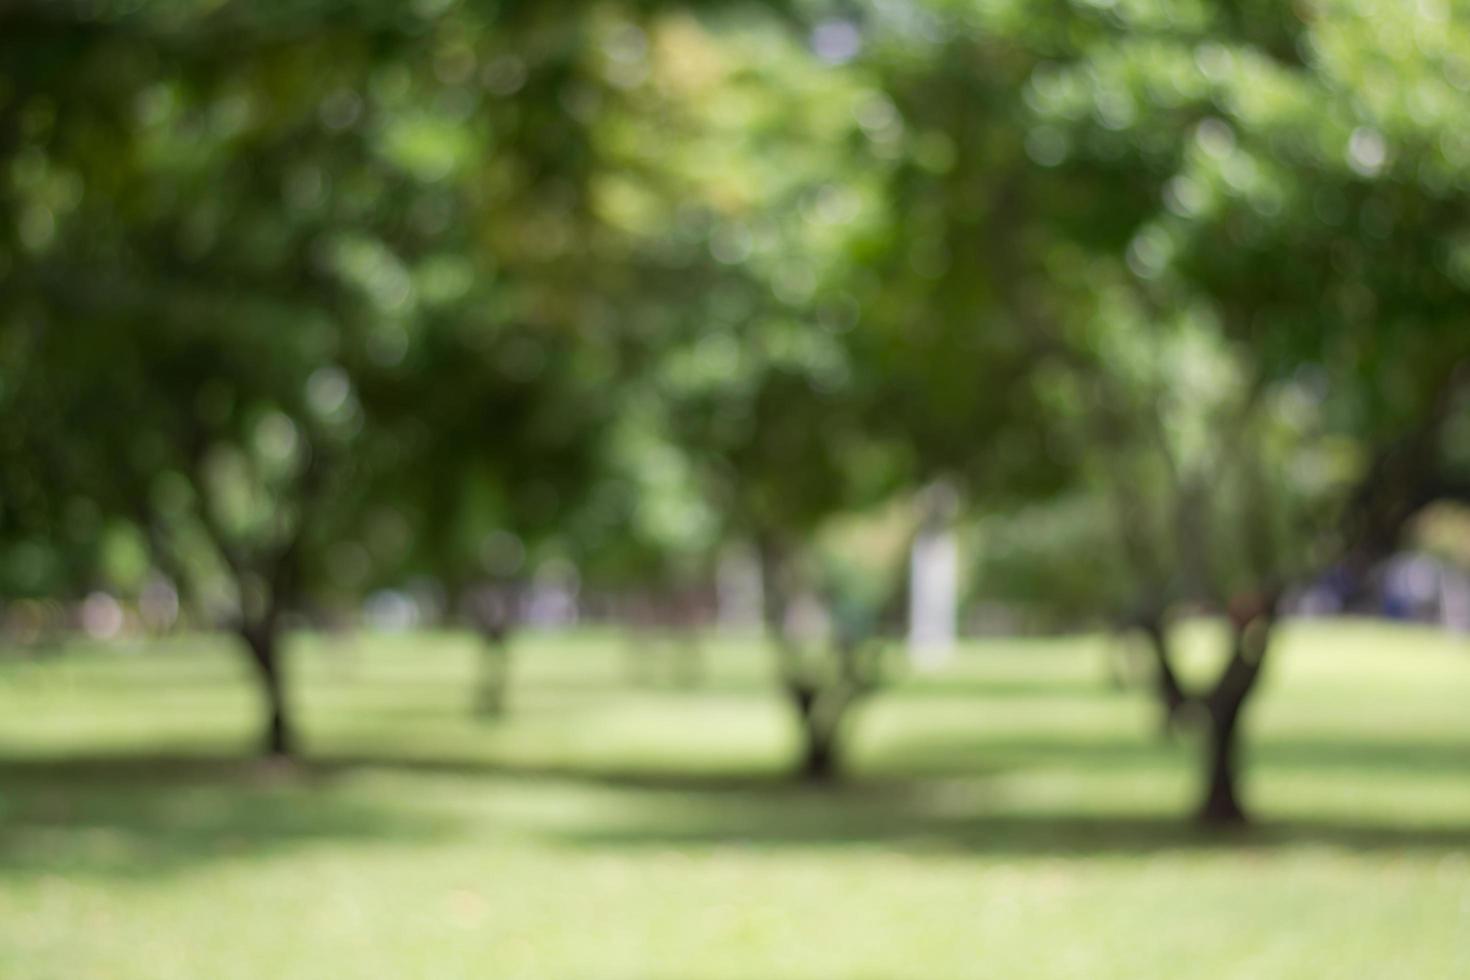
[0,0,1470,820]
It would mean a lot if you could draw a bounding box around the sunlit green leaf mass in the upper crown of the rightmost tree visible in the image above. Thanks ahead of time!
[1028,1,1470,417]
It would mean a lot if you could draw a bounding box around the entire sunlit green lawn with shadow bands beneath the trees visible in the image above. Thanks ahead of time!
[0,624,1470,980]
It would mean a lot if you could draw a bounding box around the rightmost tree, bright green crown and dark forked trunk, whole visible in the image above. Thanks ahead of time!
[1028,1,1467,823]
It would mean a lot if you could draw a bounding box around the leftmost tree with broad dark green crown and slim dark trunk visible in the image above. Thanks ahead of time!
[0,3,632,754]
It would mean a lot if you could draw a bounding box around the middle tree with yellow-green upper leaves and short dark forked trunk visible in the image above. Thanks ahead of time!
[561,11,891,779]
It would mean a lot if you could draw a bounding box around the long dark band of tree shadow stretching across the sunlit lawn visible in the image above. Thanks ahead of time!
[0,743,1470,880]
